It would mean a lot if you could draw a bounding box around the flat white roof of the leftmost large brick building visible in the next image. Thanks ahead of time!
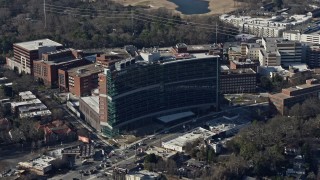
[14,39,62,51]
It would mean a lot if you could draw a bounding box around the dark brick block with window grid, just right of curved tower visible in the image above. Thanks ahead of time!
[220,68,257,94]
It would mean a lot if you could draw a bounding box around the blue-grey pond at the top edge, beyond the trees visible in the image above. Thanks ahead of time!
[169,0,210,15]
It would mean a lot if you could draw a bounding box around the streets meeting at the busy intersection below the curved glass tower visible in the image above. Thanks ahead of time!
[52,102,268,179]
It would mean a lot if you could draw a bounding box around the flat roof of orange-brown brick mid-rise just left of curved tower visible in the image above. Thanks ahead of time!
[68,64,104,77]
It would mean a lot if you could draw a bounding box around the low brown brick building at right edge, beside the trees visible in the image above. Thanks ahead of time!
[269,79,320,115]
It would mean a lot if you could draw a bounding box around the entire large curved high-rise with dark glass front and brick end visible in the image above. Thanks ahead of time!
[99,49,220,136]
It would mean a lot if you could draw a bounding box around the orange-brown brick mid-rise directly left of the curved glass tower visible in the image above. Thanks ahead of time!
[58,64,103,97]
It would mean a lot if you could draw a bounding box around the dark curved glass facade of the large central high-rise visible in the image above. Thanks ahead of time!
[100,56,220,136]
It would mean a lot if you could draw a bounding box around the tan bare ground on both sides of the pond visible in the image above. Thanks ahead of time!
[114,0,241,15]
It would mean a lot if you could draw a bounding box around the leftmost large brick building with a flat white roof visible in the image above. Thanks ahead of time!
[6,39,63,74]
